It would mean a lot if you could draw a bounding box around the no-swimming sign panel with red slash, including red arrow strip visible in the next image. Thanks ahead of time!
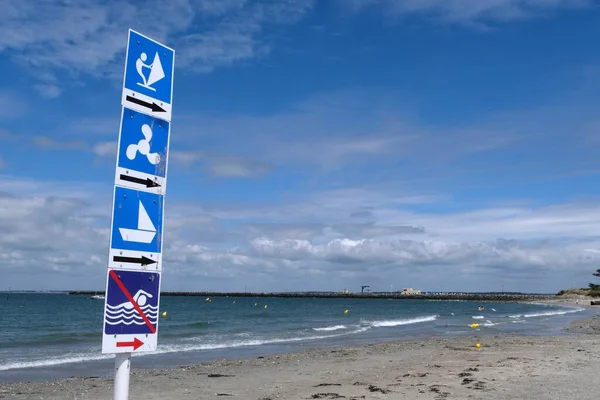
[102,269,160,353]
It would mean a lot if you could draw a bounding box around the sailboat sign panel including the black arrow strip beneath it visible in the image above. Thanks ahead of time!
[109,186,164,271]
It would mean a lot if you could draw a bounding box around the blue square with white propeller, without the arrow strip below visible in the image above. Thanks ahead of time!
[117,108,169,178]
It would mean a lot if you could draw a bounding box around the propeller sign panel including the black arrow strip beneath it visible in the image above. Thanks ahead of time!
[115,108,170,194]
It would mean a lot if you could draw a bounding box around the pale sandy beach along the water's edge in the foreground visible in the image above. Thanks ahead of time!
[0,306,600,400]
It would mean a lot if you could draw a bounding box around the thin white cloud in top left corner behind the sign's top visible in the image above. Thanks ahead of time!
[0,0,313,92]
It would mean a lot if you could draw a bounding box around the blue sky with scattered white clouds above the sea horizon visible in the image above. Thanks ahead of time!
[0,0,600,291]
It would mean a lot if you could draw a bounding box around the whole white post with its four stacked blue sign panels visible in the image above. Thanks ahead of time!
[102,29,175,400]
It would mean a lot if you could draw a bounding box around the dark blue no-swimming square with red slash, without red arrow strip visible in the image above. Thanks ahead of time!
[104,270,160,335]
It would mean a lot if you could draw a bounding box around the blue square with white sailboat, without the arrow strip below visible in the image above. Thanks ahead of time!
[111,186,164,253]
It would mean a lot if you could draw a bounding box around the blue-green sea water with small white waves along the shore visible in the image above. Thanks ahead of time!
[0,294,595,382]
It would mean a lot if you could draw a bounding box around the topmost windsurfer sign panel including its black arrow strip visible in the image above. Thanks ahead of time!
[121,29,175,121]
